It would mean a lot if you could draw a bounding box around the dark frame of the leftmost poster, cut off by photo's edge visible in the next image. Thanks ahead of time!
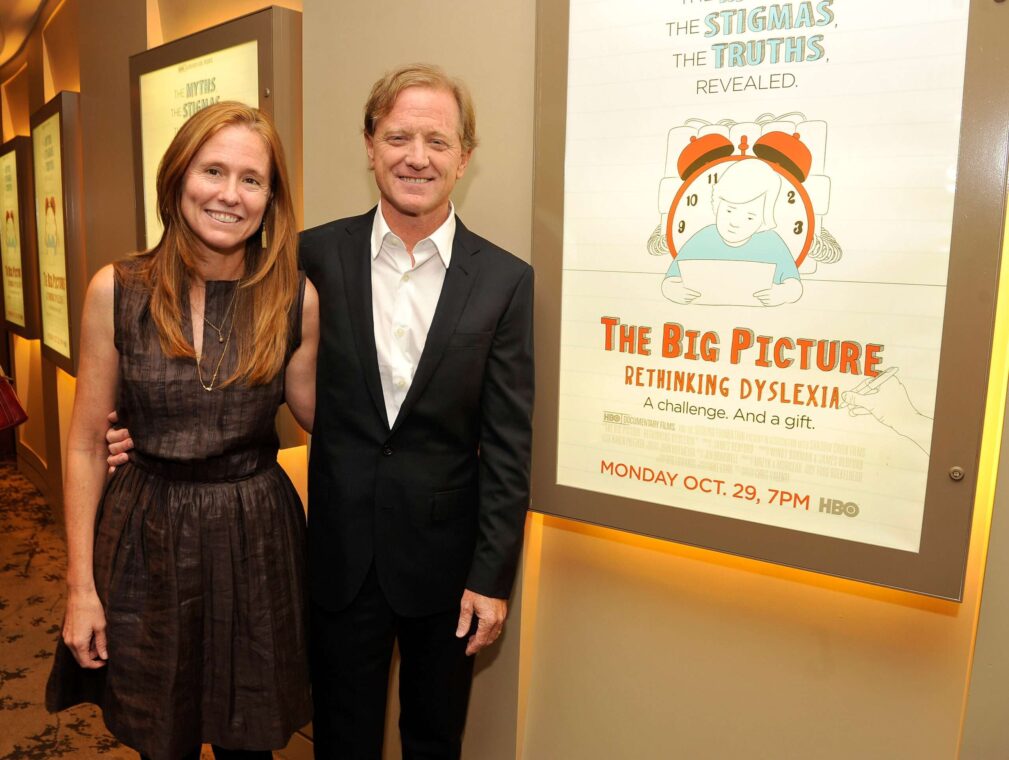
[0,136,41,340]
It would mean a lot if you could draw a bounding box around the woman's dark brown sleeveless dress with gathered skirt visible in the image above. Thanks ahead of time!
[46,262,312,760]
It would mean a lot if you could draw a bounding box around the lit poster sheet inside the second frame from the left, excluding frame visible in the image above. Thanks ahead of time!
[31,113,71,358]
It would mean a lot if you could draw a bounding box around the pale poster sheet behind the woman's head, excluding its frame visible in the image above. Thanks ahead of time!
[140,40,259,245]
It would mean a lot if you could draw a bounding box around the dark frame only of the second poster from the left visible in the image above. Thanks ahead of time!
[30,91,82,376]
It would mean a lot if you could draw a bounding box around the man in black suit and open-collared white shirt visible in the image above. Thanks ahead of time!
[302,66,533,759]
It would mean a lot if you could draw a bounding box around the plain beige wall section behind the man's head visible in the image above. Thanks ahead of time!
[304,0,536,260]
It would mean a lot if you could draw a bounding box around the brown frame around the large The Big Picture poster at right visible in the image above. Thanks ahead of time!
[532,0,1009,602]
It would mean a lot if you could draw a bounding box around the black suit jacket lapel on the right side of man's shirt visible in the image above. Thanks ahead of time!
[387,217,479,432]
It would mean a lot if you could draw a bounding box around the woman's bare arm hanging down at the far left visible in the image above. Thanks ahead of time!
[63,265,119,668]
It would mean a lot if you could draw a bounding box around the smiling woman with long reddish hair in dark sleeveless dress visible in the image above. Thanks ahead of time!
[46,102,319,760]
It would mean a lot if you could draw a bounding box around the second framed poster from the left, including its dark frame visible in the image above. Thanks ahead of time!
[31,92,84,374]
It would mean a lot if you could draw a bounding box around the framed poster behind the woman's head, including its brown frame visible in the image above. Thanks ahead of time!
[130,8,301,248]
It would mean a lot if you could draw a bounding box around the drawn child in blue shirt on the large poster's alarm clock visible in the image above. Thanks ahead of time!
[662,158,802,306]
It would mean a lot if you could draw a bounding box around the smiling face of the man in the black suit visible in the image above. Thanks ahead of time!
[364,87,471,228]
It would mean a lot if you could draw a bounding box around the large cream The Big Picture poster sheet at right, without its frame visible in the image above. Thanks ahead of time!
[557,0,969,552]
